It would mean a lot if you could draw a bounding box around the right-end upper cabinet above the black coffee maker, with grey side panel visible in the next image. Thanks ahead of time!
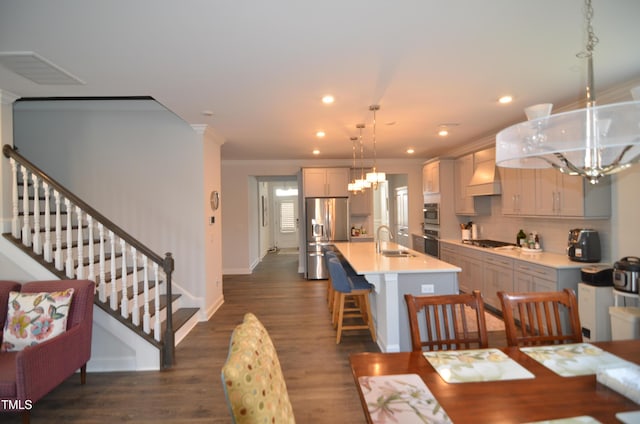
[535,168,611,217]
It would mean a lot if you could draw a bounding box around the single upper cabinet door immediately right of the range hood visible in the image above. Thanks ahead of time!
[499,168,536,215]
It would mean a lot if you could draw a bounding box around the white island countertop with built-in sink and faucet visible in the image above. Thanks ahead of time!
[334,242,461,274]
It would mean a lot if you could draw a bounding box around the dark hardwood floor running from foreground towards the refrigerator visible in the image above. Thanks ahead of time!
[0,254,505,424]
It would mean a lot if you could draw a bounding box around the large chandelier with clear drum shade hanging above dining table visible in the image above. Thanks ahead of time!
[496,0,640,184]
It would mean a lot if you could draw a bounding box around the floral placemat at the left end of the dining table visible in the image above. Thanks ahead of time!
[358,374,451,424]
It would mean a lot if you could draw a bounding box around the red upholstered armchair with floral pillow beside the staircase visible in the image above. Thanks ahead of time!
[0,280,95,423]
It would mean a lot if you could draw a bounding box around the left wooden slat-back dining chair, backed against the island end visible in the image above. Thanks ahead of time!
[404,290,488,351]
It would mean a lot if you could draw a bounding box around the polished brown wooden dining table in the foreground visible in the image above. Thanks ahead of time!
[349,340,640,424]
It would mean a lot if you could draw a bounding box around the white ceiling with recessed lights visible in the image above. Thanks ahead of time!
[0,0,640,159]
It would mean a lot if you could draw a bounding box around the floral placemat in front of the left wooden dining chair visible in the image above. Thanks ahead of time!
[424,349,534,383]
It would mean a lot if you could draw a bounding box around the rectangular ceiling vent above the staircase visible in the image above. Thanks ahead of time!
[0,52,84,85]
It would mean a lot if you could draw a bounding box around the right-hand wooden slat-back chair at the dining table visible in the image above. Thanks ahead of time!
[498,289,582,346]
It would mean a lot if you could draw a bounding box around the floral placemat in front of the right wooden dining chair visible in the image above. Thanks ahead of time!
[520,343,633,377]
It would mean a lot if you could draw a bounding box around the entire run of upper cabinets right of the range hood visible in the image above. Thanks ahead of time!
[500,168,611,218]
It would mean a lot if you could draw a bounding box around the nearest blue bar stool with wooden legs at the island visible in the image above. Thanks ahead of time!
[329,258,376,344]
